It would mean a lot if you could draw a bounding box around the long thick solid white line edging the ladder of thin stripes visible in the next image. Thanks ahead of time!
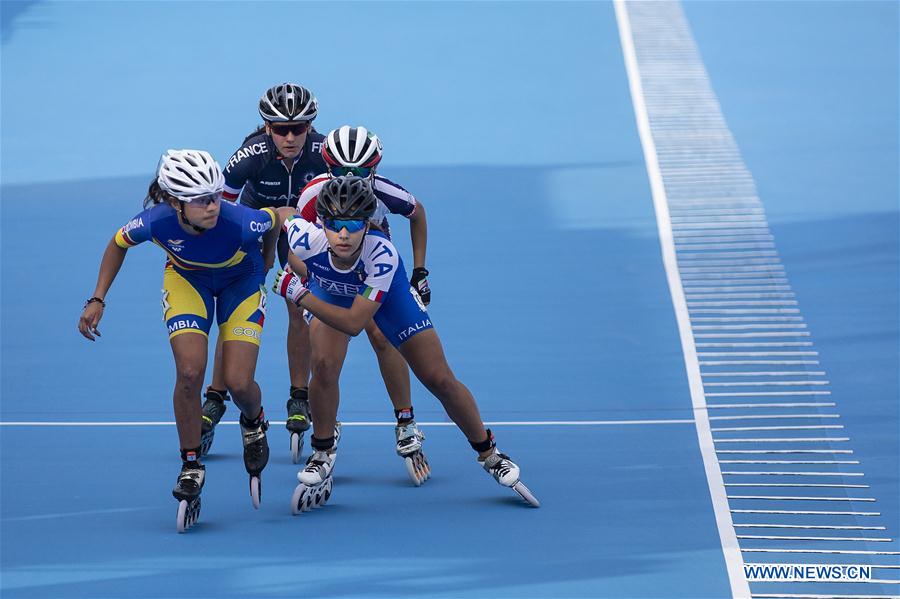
[614,0,750,597]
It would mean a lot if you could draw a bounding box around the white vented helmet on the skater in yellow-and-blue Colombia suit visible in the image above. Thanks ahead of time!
[156,150,225,202]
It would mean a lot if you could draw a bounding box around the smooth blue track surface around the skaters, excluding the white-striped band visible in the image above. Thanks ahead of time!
[0,2,900,598]
